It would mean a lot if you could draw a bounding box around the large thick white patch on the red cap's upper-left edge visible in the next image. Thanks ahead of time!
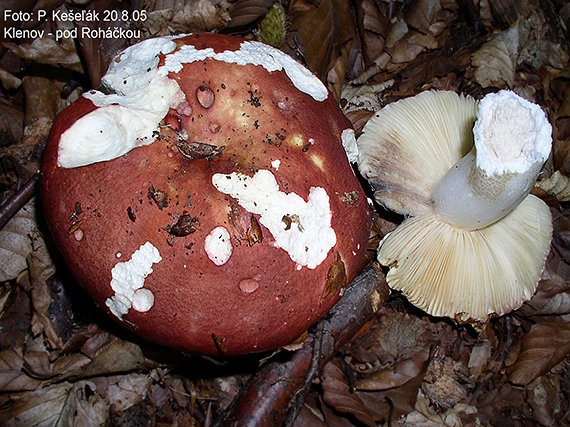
[57,37,179,168]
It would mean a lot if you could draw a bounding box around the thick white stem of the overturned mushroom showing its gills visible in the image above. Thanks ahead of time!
[433,91,552,230]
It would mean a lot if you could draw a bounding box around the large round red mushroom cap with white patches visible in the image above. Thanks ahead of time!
[41,34,371,355]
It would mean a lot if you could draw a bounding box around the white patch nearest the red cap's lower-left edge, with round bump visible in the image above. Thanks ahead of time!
[105,242,162,320]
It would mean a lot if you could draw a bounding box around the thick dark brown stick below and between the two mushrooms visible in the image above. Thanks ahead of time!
[215,266,388,427]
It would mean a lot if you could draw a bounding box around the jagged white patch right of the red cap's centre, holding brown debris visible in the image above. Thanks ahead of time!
[212,170,336,269]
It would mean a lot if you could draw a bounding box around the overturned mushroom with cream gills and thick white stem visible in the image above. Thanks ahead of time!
[357,91,552,324]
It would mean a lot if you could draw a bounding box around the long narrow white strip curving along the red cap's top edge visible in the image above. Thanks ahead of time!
[160,41,329,101]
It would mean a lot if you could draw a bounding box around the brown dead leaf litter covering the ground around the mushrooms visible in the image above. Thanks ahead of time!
[0,0,570,427]
